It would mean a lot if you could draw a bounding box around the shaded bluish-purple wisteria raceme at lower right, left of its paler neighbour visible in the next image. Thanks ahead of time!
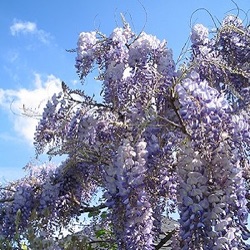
[177,146,212,249]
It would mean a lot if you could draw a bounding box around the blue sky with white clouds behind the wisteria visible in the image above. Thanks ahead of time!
[0,0,250,181]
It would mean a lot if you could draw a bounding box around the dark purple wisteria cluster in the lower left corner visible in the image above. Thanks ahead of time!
[0,162,96,240]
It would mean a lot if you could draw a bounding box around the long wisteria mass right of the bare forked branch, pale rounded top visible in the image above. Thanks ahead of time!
[176,66,249,249]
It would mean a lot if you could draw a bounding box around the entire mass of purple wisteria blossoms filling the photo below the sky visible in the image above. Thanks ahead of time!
[0,15,250,250]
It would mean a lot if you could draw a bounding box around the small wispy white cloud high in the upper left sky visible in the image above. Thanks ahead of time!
[10,19,51,44]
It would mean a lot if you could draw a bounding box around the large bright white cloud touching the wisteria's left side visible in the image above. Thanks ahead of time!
[0,74,61,144]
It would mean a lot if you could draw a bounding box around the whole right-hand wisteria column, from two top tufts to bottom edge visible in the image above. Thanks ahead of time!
[176,17,250,249]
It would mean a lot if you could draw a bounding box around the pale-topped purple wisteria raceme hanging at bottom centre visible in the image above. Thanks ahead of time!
[103,139,154,249]
